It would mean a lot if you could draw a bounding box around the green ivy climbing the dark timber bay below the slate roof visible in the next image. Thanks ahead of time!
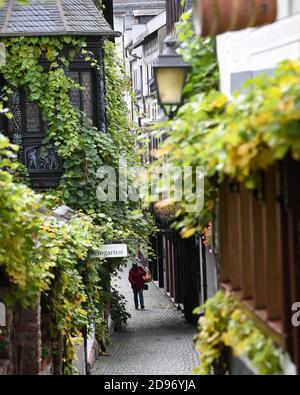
[0,37,153,254]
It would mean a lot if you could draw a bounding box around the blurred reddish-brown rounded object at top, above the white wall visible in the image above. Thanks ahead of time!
[195,0,277,37]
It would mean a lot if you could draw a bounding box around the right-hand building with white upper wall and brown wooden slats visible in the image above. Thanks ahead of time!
[217,0,300,373]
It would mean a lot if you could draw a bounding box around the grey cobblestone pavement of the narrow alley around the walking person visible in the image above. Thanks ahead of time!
[92,268,198,375]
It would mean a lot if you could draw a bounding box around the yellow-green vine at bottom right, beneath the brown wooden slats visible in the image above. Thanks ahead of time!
[194,291,284,375]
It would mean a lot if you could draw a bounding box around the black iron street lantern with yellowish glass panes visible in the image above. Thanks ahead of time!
[153,37,189,119]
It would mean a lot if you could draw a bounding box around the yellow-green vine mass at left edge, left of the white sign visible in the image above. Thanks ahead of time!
[0,134,103,372]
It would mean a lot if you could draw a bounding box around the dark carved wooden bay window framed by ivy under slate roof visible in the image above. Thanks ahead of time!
[1,42,106,190]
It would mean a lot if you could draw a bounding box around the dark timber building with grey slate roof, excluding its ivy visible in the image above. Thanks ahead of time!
[0,0,117,190]
